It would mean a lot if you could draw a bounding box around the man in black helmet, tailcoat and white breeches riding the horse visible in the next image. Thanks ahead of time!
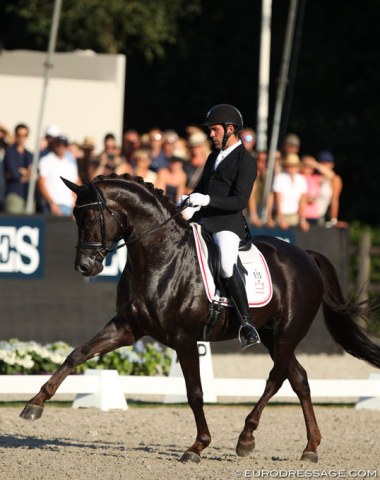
[183,104,260,349]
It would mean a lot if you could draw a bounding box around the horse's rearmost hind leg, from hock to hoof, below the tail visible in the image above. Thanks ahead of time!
[288,356,321,463]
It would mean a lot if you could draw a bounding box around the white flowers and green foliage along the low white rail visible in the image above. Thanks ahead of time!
[0,339,171,375]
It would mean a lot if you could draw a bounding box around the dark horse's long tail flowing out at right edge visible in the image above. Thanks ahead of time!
[307,250,380,368]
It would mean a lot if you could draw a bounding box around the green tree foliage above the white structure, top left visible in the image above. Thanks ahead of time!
[4,0,201,60]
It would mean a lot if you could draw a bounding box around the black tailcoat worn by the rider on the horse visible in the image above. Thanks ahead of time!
[192,145,257,238]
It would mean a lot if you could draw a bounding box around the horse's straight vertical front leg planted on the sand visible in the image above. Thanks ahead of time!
[177,342,211,463]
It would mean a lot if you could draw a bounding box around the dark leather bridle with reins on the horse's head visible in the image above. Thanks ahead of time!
[74,182,189,262]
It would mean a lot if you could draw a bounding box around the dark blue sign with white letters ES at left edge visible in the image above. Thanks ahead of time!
[0,217,45,279]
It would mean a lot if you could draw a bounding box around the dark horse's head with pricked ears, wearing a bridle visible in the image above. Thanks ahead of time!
[61,177,125,277]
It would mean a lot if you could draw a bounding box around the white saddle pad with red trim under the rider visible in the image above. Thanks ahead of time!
[191,222,273,308]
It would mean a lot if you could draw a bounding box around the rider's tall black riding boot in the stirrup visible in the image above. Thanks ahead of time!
[225,265,260,350]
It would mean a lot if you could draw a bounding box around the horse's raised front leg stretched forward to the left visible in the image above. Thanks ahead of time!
[20,316,138,420]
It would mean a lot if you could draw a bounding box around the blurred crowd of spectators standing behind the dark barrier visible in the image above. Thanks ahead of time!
[0,123,346,232]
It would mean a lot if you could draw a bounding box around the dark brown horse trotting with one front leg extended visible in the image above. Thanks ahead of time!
[21,175,380,462]
